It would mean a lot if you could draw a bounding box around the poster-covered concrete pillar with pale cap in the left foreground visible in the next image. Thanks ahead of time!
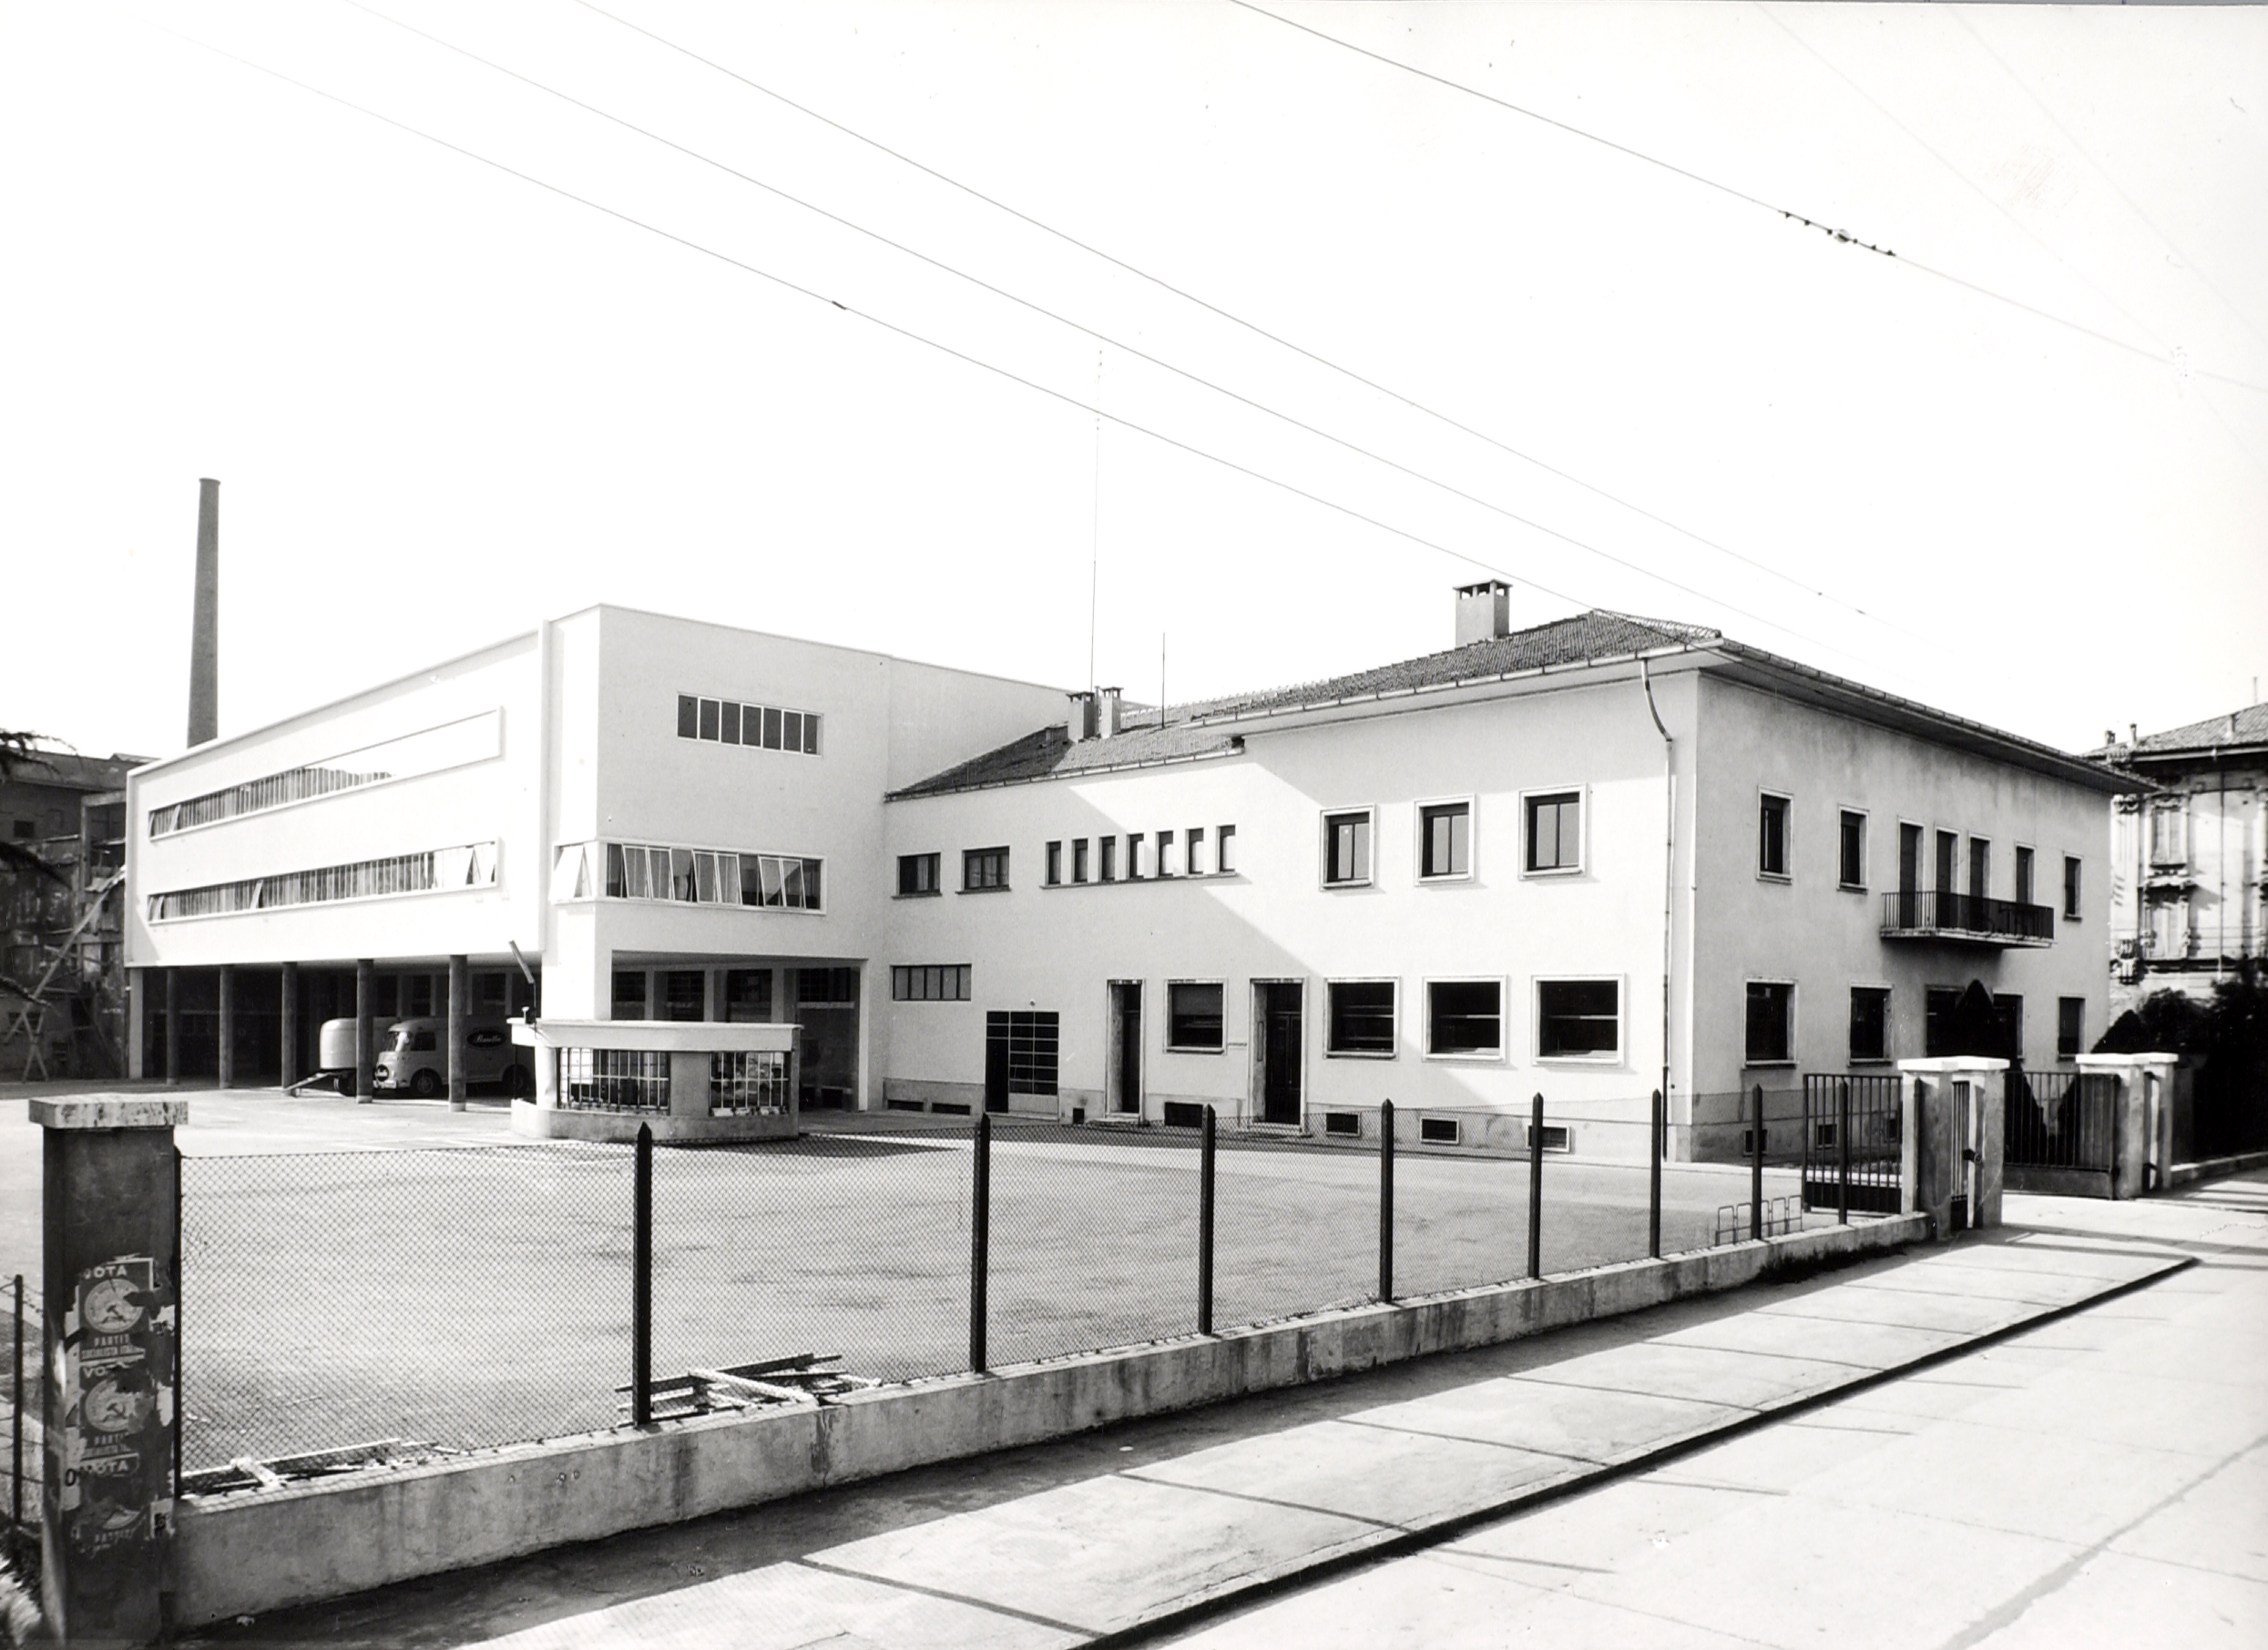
[32,1095,189,1644]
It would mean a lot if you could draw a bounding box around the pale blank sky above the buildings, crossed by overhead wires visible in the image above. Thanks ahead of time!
[0,0,2268,757]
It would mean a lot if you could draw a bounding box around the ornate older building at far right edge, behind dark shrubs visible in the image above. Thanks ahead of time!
[2091,705,2268,1018]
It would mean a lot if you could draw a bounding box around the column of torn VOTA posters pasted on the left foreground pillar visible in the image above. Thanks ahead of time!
[47,1256,175,1559]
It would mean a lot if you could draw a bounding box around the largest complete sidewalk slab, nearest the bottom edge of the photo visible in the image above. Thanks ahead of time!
[807,1473,1381,1632]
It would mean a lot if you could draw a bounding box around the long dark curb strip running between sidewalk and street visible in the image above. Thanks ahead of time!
[1082,1256,2198,1650]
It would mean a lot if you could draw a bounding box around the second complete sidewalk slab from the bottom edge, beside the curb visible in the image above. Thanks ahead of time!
[1128,1421,1589,1530]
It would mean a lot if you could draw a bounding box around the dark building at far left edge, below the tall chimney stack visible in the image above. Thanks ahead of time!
[0,746,145,1079]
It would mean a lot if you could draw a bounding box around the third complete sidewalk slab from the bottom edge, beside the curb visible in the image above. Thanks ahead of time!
[1343,1376,1749,1462]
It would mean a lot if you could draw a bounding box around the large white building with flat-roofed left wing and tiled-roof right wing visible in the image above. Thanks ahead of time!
[129,585,2120,1158]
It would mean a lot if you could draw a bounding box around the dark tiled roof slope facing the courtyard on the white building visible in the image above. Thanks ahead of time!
[892,612,1721,798]
